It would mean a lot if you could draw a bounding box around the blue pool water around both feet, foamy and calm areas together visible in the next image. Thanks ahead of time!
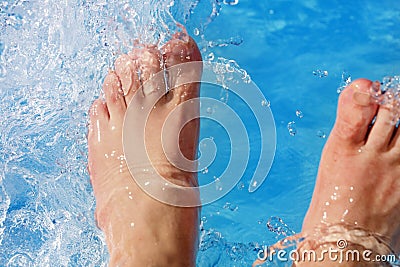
[0,0,400,266]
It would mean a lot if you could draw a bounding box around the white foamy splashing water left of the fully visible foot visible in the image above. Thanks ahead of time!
[0,0,247,266]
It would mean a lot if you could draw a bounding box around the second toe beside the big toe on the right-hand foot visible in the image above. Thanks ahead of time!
[366,106,395,151]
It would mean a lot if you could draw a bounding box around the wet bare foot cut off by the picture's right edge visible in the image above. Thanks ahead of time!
[303,79,400,262]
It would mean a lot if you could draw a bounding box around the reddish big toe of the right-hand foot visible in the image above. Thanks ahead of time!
[332,79,377,147]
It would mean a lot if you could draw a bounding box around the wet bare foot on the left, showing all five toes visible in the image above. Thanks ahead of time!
[88,36,201,266]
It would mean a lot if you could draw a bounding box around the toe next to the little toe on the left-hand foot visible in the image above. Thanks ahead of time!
[103,71,126,120]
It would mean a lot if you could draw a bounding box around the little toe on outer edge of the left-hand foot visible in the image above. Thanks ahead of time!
[88,99,109,144]
